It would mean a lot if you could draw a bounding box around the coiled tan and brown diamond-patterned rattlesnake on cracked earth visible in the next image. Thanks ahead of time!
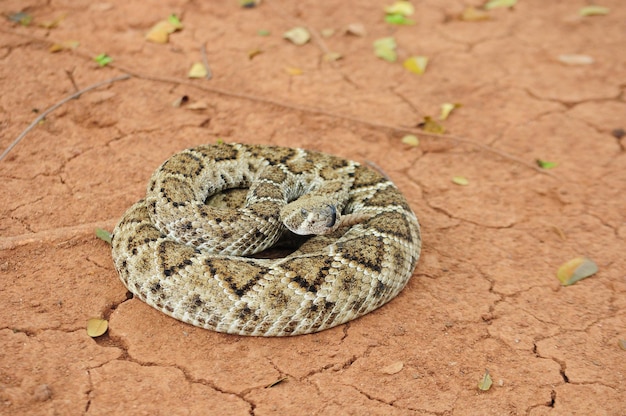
[112,143,421,336]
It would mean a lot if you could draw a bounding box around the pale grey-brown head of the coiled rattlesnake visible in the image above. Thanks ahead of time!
[280,198,340,235]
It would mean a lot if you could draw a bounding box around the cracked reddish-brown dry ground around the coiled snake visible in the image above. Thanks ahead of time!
[0,0,626,416]
